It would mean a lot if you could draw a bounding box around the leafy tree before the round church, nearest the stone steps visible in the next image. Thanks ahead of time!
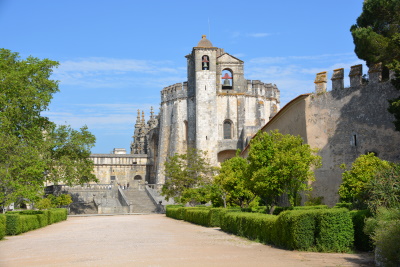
[162,148,215,203]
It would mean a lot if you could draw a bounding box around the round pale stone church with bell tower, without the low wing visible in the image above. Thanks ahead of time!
[150,35,279,184]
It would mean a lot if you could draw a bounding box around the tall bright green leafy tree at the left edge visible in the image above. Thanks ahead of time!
[0,49,58,209]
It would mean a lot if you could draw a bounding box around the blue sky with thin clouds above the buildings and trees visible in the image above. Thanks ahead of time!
[0,0,366,153]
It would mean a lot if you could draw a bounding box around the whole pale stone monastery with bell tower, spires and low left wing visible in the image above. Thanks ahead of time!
[91,35,280,184]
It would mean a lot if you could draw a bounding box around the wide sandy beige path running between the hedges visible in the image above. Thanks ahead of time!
[0,215,371,267]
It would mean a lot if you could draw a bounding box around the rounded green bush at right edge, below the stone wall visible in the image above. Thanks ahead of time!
[366,164,400,212]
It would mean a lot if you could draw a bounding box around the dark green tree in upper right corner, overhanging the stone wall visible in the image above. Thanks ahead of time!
[350,0,400,131]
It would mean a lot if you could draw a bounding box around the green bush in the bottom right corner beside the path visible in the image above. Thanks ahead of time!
[365,208,400,266]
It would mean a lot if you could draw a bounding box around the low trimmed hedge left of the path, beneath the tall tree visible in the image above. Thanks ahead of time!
[5,209,68,235]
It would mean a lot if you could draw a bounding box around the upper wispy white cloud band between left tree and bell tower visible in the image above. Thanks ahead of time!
[53,58,186,90]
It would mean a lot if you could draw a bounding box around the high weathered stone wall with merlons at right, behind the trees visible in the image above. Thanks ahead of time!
[243,65,400,205]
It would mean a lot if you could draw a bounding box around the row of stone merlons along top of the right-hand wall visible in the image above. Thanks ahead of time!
[314,63,394,93]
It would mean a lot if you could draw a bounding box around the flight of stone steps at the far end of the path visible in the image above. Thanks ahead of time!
[124,188,157,213]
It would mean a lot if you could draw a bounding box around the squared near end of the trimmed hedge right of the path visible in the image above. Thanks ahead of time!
[315,208,354,252]
